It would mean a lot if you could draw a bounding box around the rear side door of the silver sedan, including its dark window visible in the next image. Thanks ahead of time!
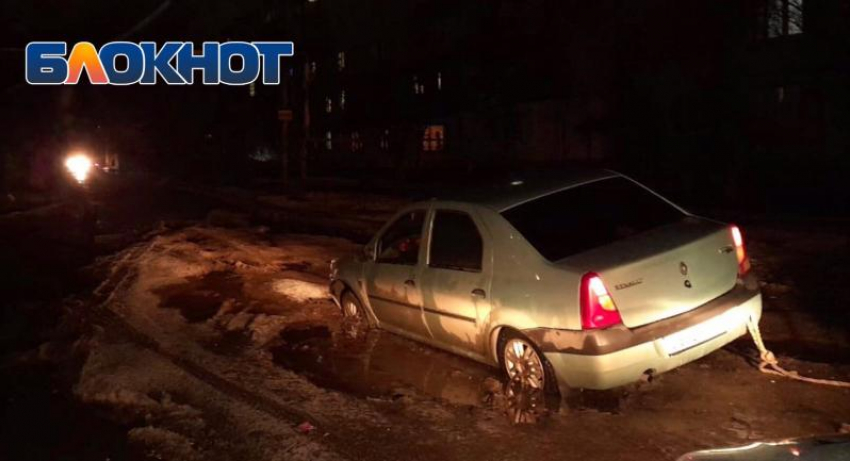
[422,208,491,354]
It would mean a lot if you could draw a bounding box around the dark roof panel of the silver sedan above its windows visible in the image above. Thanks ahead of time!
[434,169,622,212]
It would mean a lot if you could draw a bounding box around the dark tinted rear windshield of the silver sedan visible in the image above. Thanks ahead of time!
[502,177,685,261]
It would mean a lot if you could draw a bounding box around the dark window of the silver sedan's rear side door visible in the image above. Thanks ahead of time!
[428,210,484,272]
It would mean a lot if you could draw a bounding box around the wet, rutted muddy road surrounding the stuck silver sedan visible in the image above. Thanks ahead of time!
[3,178,850,460]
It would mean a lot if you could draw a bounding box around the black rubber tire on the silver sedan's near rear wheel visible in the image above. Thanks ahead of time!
[496,329,559,394]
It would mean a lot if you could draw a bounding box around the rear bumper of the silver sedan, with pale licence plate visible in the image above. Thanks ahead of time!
[525,279,762,389]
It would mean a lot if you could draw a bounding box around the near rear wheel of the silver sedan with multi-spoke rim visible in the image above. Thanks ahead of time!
[498,330,558,393]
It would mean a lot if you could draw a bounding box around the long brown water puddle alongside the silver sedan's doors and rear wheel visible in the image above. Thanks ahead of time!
[272,324,559,423]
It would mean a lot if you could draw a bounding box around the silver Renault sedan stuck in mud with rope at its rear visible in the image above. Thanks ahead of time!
[330,170,762,394]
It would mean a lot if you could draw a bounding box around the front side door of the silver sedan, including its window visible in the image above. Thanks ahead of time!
[365,209,429,338]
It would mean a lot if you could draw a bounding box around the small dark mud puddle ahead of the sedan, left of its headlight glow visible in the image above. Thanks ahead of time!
[154,271,243,323]
